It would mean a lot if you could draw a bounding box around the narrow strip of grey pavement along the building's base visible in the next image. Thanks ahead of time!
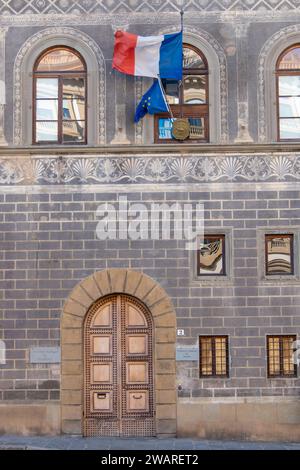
[0,435,300,451]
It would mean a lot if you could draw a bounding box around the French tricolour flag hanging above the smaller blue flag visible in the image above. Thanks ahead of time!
[112,31,182,80]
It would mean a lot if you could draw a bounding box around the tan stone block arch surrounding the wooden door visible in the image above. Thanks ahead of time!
[61,269,177,437]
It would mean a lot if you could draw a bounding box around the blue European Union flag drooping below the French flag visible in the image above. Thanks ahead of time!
[134,80,169,122]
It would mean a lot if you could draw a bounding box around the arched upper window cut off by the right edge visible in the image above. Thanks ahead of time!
[276,44,300,141]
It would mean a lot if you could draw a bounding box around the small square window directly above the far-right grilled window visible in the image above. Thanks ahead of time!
[266,235,293,275]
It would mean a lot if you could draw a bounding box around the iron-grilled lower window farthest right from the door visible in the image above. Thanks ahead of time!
[267,335,297,377]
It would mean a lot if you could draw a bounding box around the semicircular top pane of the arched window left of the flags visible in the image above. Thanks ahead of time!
[37,49,84,72]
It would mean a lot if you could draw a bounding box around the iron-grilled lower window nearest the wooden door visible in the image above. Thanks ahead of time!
[199,336,229,377]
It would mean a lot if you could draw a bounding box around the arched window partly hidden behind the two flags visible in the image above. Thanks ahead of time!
[155,44,209,143]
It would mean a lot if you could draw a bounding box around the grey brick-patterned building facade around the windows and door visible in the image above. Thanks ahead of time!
[0,0,300,440]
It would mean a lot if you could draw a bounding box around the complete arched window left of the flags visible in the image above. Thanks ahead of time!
[33,46,87,144]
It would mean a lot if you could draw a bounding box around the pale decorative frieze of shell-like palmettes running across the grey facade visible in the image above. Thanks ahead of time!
[0,153,300,185]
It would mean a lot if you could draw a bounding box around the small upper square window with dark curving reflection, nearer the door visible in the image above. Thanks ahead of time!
[197,235,225,276]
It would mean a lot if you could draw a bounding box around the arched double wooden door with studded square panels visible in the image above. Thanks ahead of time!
[84,294,155,437]
